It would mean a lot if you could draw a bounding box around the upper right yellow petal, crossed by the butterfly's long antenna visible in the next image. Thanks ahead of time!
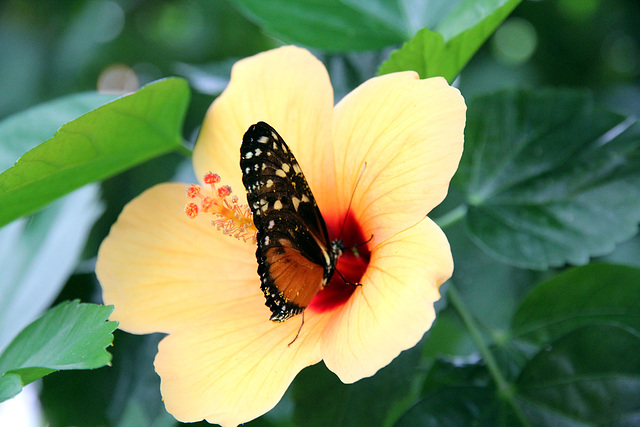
[333,72,466,243]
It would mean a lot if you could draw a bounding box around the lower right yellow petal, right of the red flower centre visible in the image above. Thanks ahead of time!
[322,218,453,383]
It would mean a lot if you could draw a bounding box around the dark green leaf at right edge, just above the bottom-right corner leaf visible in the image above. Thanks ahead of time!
[513,264,640,345]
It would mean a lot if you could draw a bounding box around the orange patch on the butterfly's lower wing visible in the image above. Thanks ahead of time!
[267,247,324,308]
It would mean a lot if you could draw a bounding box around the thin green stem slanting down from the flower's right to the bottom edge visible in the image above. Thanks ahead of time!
[447,282,531,427]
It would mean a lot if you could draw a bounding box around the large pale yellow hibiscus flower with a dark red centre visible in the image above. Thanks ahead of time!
[96,46,466,426]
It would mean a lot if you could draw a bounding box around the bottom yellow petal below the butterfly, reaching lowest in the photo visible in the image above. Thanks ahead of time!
[155,305,325,427]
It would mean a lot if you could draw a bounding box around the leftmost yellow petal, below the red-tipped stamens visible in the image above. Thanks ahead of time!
[96,184,270,334]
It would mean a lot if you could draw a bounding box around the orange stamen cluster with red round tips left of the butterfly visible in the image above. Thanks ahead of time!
[184,172,257,243]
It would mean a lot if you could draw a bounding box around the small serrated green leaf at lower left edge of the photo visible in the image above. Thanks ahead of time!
[0,301,118,402]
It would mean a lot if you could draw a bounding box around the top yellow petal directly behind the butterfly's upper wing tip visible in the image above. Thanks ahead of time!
[193,46,333,211]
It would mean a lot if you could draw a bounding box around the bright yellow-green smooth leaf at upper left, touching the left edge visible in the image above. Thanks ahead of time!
[0,78,189,226]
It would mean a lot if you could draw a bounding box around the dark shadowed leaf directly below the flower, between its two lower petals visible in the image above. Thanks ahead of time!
[293,346,420,427]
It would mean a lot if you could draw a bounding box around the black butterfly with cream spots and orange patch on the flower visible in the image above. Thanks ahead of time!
[240,122,344,322]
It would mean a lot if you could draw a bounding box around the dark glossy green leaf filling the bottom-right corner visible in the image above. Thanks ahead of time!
[515,326,640,427]
